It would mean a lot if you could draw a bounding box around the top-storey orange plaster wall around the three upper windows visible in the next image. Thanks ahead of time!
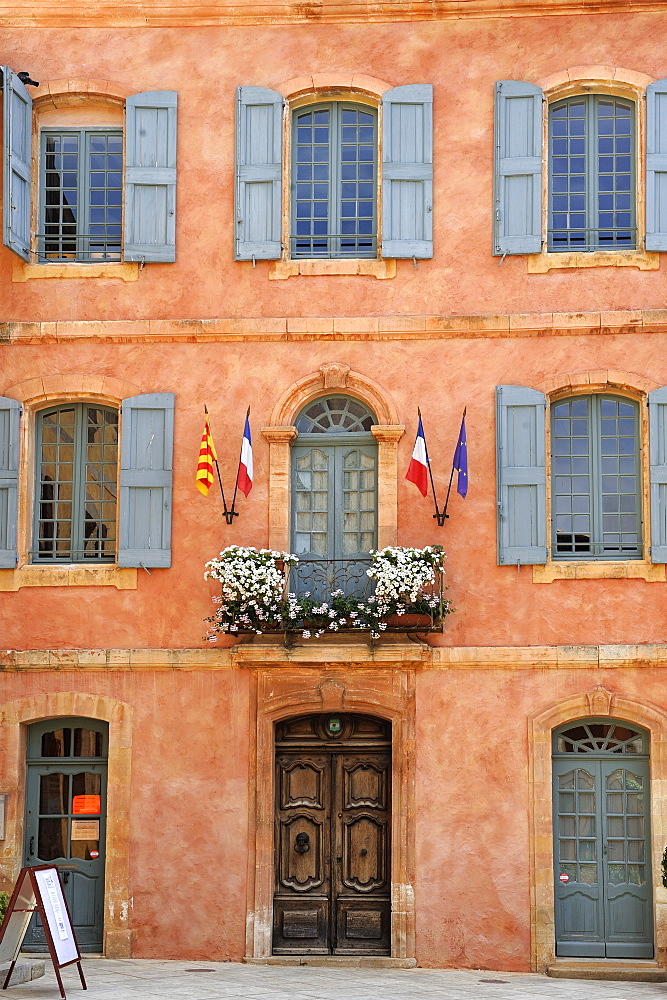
[0,13,667,320]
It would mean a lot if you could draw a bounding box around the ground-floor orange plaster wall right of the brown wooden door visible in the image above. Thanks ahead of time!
[415,669,664,972]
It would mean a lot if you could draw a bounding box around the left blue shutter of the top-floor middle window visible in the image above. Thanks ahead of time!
[234,87,283,260]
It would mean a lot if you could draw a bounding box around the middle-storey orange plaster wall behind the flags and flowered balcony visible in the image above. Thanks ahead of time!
[0,334,667,649]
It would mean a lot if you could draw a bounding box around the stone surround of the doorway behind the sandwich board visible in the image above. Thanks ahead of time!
[0,691,132,958]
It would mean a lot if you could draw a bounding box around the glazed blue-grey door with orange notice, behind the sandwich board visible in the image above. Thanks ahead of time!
[23,718,109,952]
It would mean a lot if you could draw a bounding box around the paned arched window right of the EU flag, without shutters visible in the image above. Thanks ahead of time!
[551,395,642,559]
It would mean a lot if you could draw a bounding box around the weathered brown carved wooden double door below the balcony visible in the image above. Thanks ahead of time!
[273,714,391,955]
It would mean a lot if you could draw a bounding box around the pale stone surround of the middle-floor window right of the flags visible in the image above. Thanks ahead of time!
[532,369,667,583]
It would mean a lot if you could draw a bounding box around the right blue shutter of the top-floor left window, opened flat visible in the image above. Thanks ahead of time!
[123,90,178,263]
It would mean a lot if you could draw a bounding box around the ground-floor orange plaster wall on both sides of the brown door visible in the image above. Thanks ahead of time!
[0,668,664,971]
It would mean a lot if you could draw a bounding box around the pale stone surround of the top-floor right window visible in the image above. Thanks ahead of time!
[526,65,660,274]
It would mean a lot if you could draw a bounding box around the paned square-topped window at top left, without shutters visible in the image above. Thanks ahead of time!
[38,129,123,262]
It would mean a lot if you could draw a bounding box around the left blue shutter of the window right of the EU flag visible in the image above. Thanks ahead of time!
[496,385,547,566]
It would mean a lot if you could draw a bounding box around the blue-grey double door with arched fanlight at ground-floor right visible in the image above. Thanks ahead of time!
[553,718,653,958]
